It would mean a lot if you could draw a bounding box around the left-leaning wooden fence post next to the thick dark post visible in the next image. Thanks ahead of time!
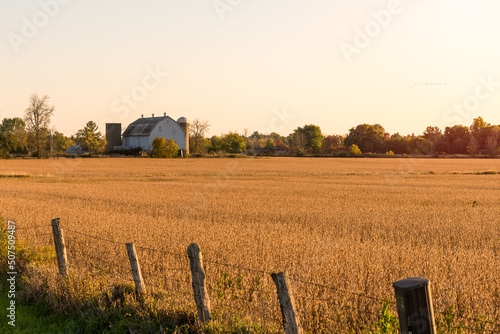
[271,271,302,334]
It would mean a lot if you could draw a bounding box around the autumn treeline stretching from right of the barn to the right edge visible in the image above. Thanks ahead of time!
[190,117,500,156]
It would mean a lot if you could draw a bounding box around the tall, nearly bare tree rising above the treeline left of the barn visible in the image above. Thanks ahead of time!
[24,94,54,159]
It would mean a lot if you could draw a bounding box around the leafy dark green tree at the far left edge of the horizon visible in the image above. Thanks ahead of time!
[0,117,26,157]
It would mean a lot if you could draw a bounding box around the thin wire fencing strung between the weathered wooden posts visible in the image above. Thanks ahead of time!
[6,224,500,333]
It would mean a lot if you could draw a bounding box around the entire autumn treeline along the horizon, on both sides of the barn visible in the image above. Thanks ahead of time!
[0,94,500,158]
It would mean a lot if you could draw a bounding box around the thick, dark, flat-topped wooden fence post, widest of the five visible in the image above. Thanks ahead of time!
[392,277,436,334]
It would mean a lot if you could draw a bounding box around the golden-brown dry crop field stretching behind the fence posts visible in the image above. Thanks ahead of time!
[0,158,500,333]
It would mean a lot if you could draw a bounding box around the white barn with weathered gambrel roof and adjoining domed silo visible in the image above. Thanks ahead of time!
[122,114,189,154]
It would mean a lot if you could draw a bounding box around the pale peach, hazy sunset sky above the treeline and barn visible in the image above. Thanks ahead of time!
[0,0,500,135]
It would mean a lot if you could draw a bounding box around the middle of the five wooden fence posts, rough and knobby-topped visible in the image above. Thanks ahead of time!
[188,244,212,322]
